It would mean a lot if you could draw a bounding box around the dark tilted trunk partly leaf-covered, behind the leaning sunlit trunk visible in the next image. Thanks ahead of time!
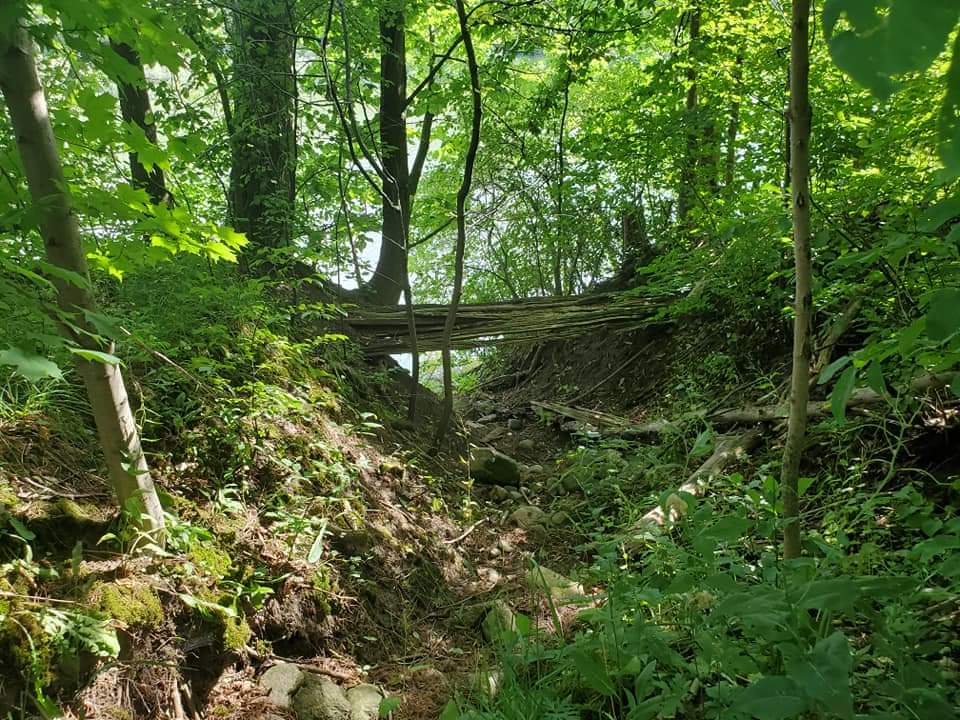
[110,39,173,205]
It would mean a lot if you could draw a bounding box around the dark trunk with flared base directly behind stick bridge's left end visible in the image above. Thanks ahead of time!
[369,2,410,305]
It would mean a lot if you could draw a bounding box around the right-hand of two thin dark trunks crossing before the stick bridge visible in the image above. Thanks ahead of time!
[437,0,483,445]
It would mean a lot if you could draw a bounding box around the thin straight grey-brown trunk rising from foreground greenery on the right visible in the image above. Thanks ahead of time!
[780,0,813,559]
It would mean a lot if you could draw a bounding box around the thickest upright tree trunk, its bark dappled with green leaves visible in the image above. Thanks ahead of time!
[230,0,296,273]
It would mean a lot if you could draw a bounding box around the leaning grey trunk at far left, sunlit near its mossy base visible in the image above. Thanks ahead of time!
[0,28,164,546]
